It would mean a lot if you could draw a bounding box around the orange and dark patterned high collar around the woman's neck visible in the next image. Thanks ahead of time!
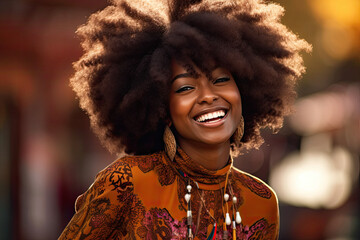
[172,147,232,190]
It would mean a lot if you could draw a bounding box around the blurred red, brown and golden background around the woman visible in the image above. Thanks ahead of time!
[0,0,360,240]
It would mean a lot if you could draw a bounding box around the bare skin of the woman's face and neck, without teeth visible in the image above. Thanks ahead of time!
[169,60,242,170]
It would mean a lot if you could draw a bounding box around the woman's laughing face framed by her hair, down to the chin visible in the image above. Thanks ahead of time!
[169,61,241,146]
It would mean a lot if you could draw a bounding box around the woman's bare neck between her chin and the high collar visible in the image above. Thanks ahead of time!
[179,141,230,170]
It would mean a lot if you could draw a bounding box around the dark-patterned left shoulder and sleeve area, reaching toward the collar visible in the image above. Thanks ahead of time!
[60,154,165,239]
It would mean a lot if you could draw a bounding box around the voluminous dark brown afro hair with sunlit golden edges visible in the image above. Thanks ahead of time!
[70,0,311,154]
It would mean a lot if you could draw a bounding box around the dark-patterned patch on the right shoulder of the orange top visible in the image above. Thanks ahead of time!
[232,167,277,204]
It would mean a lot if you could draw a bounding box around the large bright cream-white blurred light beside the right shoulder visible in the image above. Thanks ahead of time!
[270,135,359,209]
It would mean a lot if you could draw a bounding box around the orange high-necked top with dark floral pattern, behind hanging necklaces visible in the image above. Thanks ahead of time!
[59,149,279,240]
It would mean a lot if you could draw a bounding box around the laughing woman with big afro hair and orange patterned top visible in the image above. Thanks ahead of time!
[59,0,310,239]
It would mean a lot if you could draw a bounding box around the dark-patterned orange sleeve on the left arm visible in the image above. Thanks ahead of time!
[59,162,139,240]
